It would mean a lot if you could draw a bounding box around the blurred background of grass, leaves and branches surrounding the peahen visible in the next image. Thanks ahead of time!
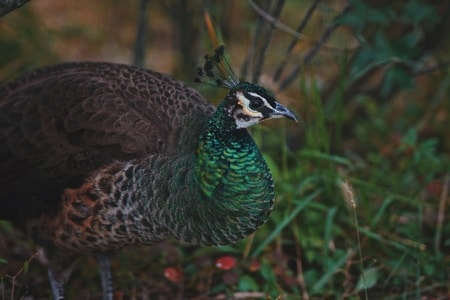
[0,0,450,299]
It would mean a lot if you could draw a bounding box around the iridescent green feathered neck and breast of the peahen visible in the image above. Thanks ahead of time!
[186,103,274,244]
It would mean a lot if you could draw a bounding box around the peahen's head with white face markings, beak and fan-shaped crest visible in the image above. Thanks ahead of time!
[196,46,298,128]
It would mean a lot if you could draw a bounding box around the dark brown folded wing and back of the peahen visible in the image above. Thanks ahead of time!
[0,63,214,218]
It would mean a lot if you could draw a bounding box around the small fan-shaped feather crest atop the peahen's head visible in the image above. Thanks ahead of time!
[195,45,239,90]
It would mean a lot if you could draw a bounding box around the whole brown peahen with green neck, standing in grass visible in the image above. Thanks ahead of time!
[0,47,297,299]
